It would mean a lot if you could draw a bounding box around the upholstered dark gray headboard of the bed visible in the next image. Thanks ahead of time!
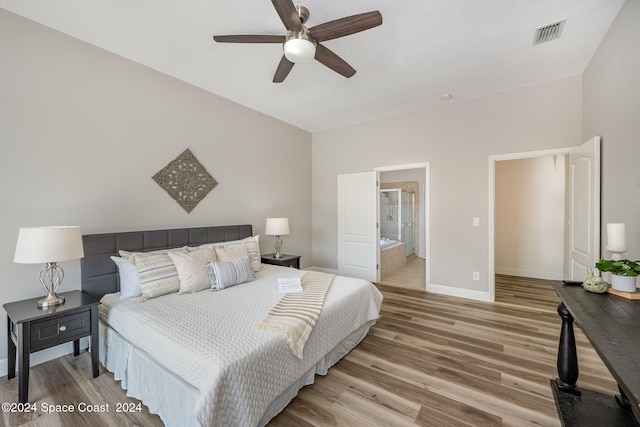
[80,225,253,298]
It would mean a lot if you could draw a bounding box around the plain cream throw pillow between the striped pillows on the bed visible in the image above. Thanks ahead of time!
[167,248,216,294]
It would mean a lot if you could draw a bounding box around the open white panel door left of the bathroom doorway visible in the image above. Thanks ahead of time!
[338,171,379,282]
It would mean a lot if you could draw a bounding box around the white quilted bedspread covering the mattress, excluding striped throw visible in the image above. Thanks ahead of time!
[100,265,382,426]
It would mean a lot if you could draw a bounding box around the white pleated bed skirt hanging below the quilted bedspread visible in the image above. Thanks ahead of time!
[99,320,375,427]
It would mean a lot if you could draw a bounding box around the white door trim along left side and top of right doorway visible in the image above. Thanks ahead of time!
[487,147,575,302]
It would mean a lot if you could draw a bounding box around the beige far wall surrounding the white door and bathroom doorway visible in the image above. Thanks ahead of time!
[312,76,583,296]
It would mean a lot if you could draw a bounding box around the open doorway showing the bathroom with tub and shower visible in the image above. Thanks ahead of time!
[378,164,429,291]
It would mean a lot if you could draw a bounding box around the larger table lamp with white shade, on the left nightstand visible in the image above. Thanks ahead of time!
[13,226,84,308]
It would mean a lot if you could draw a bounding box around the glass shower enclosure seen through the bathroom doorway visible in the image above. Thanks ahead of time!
[380,189,415,257]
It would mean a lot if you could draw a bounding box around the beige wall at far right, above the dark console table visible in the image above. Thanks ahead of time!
[583,0,640,259]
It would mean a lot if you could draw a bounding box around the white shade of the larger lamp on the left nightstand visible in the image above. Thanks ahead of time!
[13,226,84,264]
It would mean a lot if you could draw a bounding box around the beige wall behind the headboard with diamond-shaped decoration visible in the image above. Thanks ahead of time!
[0,10,311,364]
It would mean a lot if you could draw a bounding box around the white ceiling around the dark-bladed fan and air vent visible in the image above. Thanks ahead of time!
[0,0,624,132]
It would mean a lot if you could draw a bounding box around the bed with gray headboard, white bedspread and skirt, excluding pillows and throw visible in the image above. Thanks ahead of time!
[81,225,382,426]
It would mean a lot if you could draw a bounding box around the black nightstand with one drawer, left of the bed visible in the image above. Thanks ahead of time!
[4,291,100,403]
